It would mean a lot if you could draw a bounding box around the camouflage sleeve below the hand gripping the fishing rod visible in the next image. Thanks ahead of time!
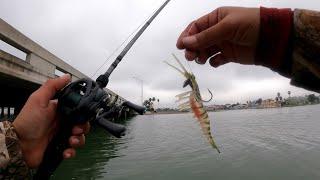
[0,121,32,179]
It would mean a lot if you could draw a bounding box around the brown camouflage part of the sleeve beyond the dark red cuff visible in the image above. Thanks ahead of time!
[291,9,320,92]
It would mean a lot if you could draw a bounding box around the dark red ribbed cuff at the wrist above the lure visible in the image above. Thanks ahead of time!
[255,7,293,71]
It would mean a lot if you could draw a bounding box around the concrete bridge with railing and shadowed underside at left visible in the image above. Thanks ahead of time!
[0,18,124,118]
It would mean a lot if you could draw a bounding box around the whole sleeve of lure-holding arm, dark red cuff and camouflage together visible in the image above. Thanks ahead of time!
[255,7,320,92]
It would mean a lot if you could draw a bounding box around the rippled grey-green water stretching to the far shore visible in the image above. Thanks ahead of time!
[53,105,320,180]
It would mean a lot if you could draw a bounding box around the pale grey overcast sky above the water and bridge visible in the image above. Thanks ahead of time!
[0,0,320,106]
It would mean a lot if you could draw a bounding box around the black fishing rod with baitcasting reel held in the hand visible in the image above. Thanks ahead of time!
[33,0,170,180]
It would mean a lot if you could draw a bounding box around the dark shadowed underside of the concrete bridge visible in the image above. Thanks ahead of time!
[0,72,40,119]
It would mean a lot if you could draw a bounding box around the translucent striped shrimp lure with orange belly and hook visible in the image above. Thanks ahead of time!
[165,54,220,153]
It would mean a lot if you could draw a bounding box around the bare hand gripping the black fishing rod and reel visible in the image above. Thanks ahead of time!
[13,75,90,169]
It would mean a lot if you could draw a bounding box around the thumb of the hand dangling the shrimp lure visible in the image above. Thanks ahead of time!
[182,20,231,51]
